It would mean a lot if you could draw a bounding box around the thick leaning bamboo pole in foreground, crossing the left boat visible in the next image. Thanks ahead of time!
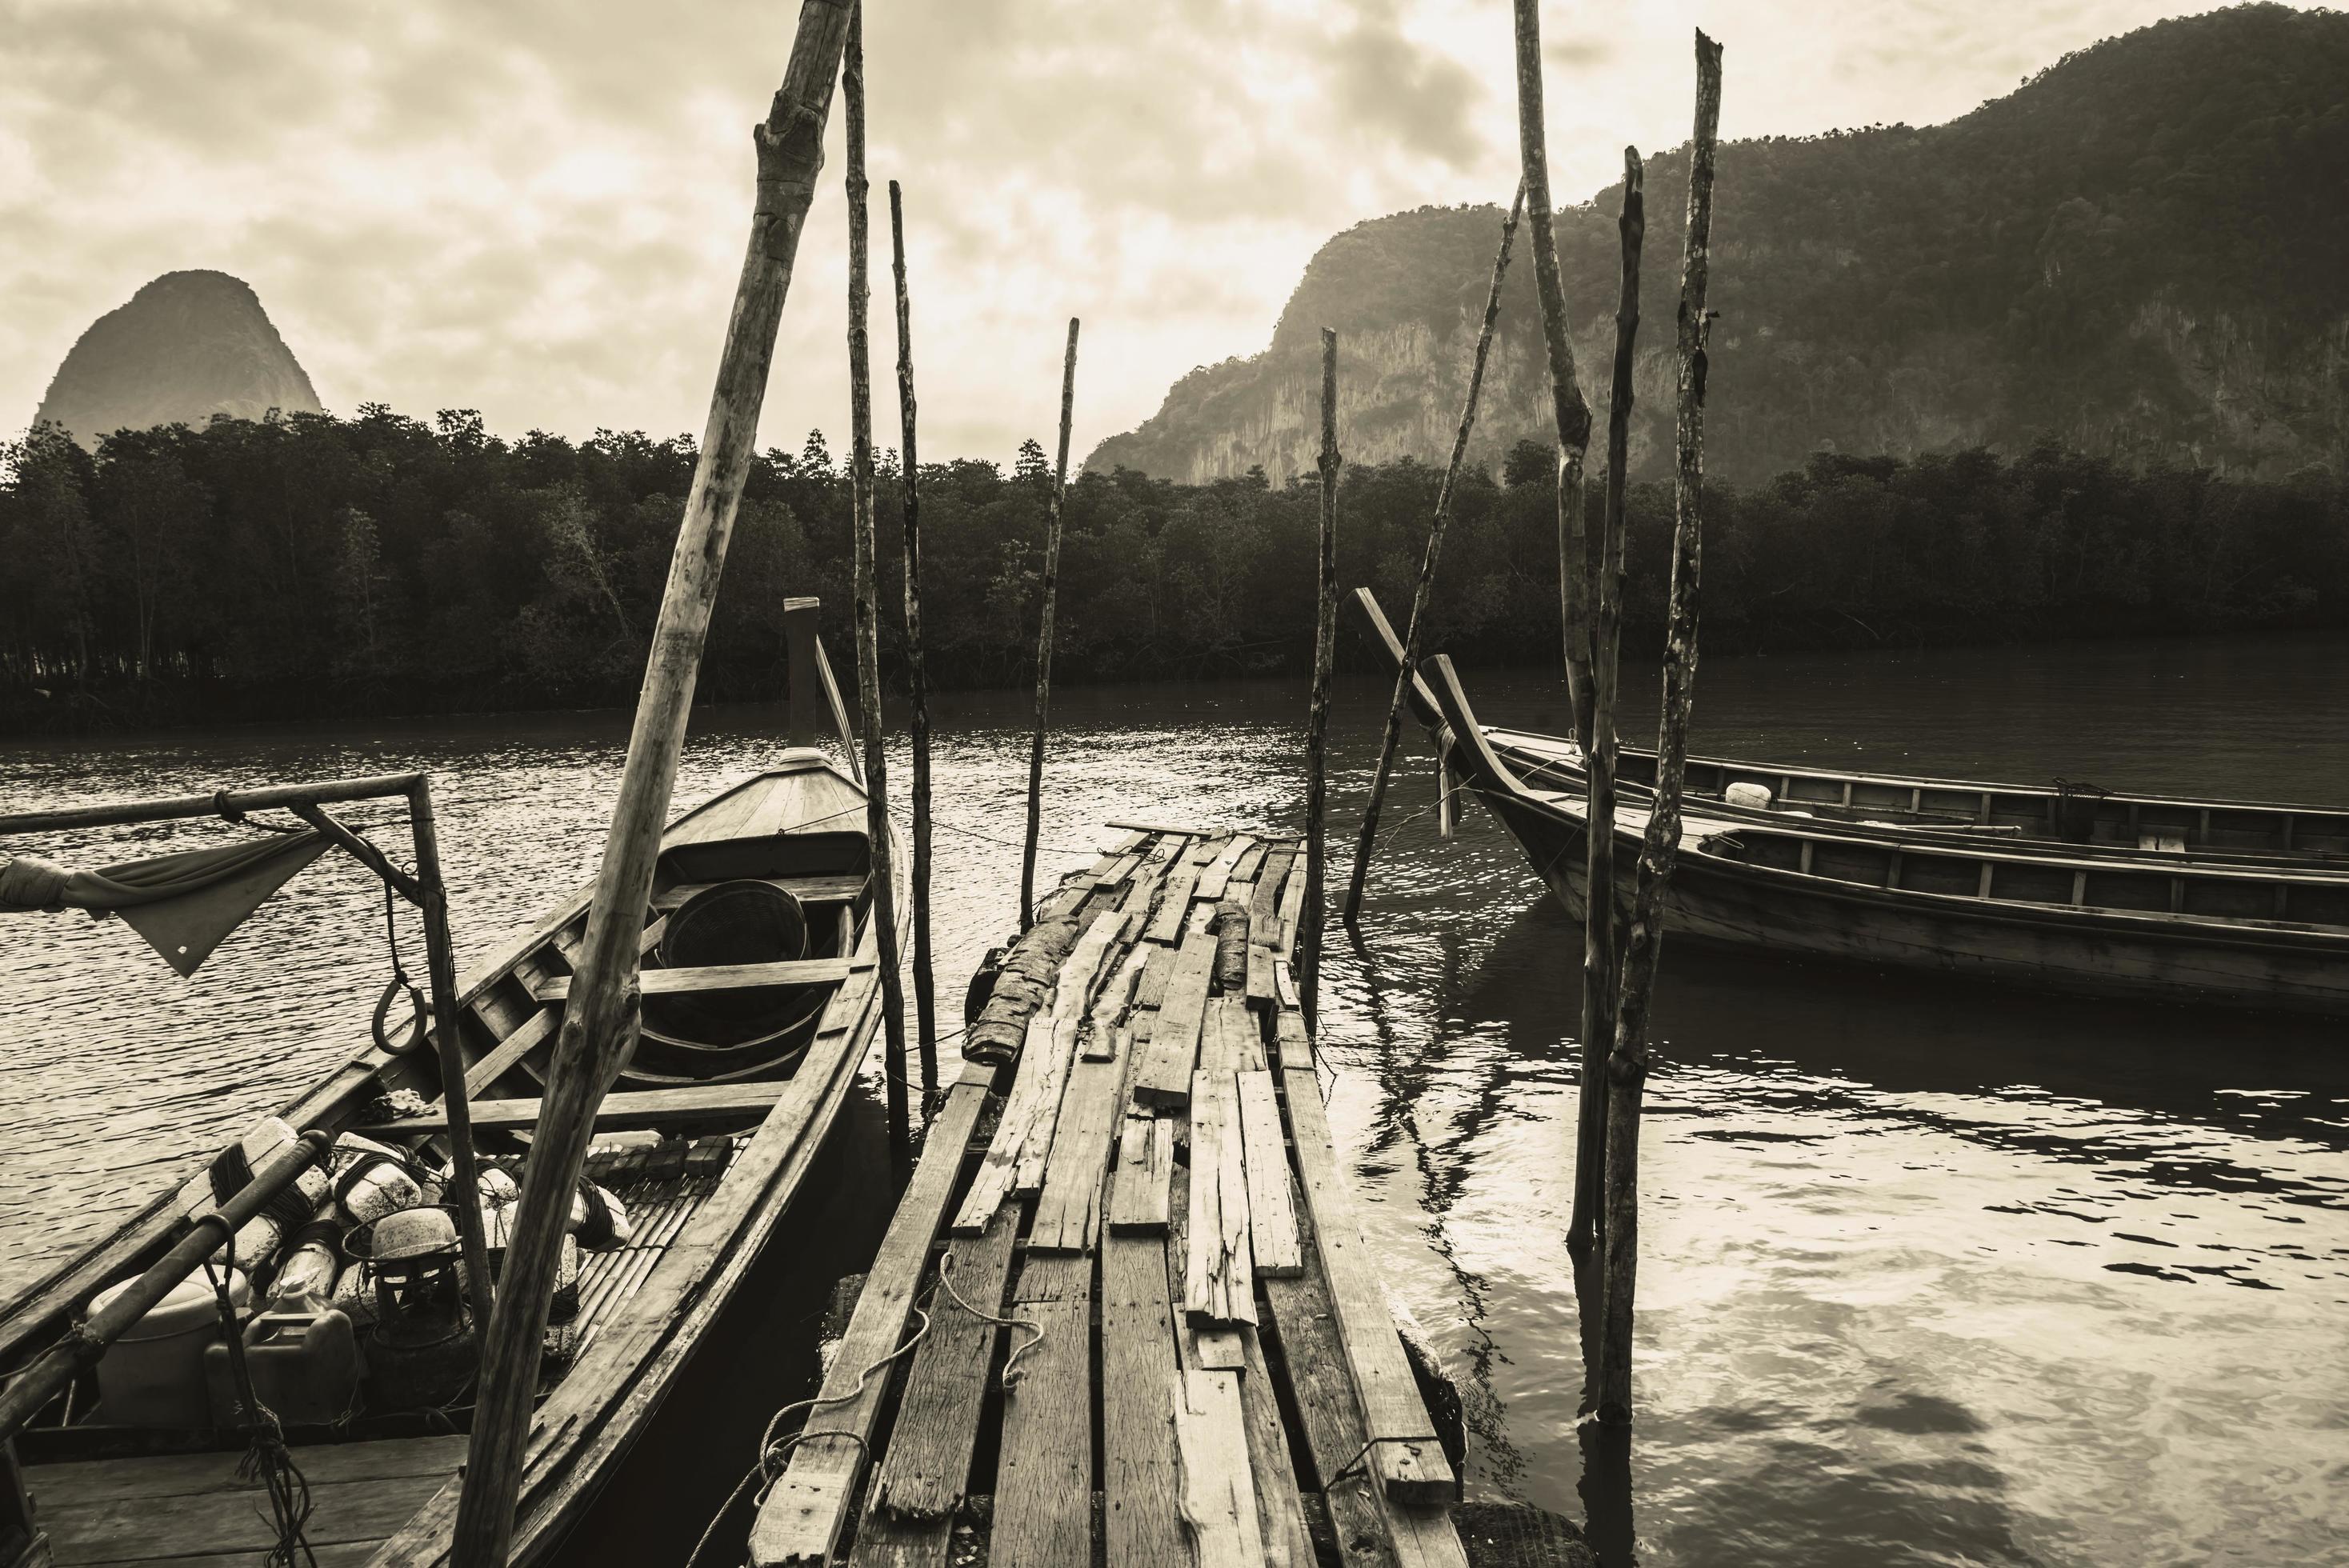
[454,0,848,1568]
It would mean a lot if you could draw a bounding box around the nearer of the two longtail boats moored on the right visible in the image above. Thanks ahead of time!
[1426,659,2349,1014]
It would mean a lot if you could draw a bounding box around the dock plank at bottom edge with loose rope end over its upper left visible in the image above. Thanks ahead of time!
[989,1256,1094,1568]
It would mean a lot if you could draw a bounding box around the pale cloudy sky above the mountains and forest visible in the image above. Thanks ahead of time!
[0,0,2255,458]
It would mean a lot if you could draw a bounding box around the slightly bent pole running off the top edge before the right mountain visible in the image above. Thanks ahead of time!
[1515,0,1595,746]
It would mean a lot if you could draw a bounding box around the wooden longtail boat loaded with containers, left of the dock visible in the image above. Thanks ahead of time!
[0,601,902,1566]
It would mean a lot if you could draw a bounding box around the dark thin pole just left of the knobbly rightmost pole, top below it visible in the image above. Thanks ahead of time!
[1567,148,1647,1251]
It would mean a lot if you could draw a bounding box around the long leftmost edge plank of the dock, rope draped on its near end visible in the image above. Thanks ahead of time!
[750,1082,986,1568]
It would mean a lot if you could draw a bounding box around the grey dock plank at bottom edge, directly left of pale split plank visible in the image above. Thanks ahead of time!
[1102,1239,1191,1568]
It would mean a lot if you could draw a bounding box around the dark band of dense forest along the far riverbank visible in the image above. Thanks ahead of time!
[0,406,2349,732]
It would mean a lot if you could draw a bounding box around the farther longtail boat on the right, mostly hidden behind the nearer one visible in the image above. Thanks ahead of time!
[1353,589,2349,864]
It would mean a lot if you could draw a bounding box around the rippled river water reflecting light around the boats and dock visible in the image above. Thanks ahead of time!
[0,638,2349,1568]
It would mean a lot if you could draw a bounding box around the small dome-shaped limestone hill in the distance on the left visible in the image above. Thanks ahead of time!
[35,272,324,448]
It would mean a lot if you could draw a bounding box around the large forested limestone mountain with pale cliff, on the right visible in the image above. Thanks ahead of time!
[1087,5,2349,481]
